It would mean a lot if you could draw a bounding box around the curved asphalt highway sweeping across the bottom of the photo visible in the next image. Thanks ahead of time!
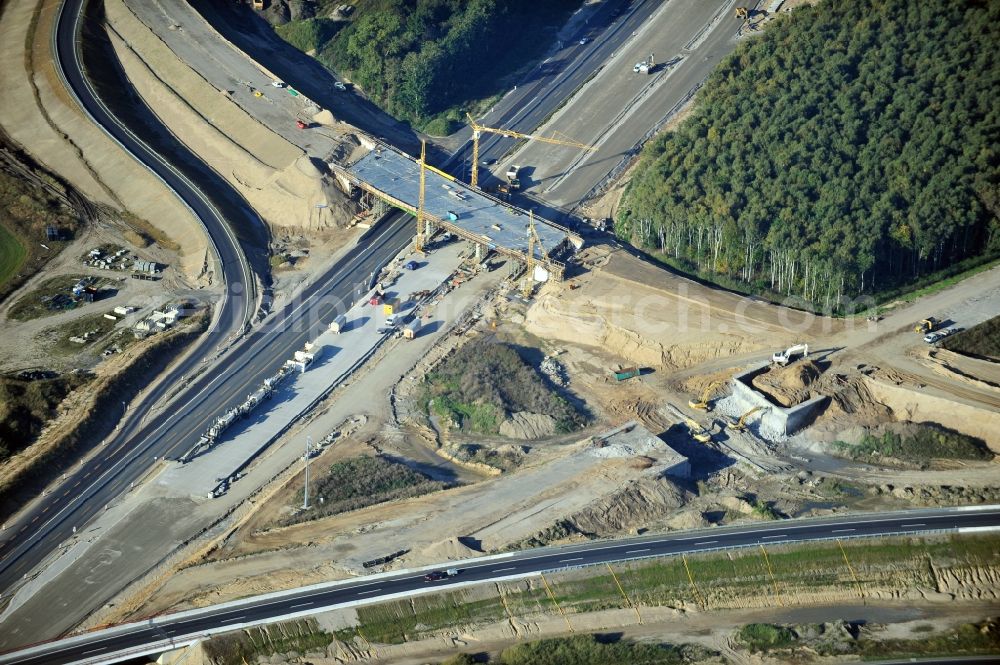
[0,506,1000,665]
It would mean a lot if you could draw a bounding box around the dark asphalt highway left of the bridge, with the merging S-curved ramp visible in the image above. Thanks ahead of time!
[0,0,413,608]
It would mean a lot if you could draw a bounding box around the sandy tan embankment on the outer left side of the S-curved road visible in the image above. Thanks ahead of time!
[0,0,208,279]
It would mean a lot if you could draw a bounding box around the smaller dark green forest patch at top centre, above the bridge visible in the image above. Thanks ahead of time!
[278,0,581,133]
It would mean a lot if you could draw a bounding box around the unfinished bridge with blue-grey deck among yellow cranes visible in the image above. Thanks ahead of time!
[329,144,583,279]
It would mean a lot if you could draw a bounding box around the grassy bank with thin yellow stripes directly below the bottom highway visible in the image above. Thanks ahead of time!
[338,534,1000,644]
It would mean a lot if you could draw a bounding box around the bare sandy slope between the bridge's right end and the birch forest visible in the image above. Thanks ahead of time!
[525,247,839,369]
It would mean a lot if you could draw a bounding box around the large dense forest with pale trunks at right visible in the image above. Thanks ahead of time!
[615,0,1000,311]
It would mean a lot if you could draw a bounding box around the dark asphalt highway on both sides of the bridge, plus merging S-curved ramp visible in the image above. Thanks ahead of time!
[0,0,672,612]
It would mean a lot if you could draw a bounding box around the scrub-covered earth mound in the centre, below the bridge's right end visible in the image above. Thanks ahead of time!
[421,341,585,434]
